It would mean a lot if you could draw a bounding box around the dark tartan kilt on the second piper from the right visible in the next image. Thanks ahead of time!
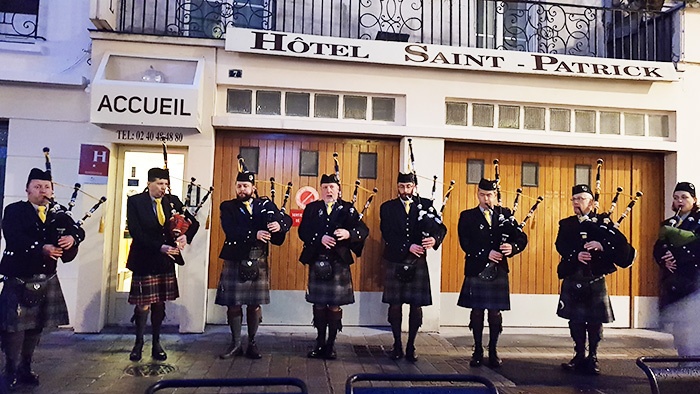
[557,277,615,323]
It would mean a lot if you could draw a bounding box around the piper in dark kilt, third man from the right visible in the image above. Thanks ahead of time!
[457,179,527,368]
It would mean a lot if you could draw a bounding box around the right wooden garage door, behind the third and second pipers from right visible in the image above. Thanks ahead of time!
[441,144,664,296]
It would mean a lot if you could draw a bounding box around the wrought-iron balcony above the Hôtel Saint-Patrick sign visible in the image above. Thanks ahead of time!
[113,0,683,62]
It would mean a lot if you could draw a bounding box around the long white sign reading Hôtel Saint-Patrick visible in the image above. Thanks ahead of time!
[226,28,678,81]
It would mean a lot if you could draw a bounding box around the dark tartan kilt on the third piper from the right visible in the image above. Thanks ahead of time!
[457,269,510,311]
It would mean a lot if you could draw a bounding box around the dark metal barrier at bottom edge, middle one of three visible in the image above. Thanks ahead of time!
[345,373,498,394]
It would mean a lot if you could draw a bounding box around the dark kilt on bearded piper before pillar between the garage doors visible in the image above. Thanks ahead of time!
[382,255,433,306]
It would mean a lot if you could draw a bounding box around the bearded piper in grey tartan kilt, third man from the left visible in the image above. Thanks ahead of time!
[215,171,289,359]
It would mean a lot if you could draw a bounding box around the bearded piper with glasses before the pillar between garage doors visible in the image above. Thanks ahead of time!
[379,173,447,362]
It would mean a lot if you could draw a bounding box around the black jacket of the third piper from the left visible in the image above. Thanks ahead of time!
[219,198,289,261]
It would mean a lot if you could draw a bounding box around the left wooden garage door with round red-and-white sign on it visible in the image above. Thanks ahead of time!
[209,131,399,291]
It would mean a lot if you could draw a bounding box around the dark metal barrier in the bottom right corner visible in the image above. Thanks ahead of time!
[637,356,700,394]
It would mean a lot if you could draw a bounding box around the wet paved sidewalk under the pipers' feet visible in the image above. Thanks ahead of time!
[13,326,676,394]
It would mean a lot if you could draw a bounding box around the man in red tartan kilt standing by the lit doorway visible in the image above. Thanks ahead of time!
[126,168,199,361]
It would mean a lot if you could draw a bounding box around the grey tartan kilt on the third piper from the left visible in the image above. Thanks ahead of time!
[214,260,270,306]
